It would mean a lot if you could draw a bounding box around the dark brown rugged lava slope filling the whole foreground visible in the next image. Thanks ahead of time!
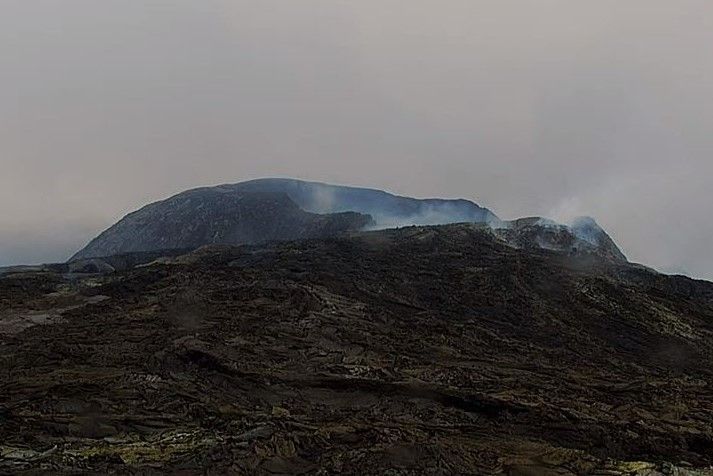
[0,223,713,475]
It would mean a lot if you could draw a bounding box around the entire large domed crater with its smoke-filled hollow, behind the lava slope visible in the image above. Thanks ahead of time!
[71,179,498,260]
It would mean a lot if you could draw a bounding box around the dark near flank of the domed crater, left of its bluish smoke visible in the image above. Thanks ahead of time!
[72,187,373,260]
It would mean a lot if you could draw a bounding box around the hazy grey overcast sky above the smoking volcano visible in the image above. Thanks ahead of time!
[0,0,713,279]
